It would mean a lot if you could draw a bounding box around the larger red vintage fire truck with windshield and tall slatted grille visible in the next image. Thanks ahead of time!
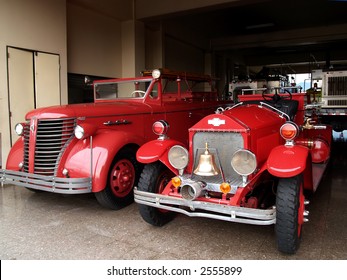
[0,69,234,209]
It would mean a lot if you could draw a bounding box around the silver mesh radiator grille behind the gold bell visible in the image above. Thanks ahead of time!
[193,131,244,186]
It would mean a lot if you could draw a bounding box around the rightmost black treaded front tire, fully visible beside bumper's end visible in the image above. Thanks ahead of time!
[275,175,305,254]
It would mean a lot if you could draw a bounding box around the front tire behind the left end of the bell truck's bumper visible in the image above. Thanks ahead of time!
[138,162,175,226]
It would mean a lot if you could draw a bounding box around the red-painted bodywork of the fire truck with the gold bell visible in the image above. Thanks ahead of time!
[138,93,332,208]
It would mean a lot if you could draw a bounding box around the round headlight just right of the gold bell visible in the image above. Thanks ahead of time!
[231,150,257,176]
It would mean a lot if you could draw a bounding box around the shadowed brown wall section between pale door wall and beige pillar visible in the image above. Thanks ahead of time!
[67,3,122,77]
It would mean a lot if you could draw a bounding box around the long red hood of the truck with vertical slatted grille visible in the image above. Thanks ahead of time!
[25,101,152,120]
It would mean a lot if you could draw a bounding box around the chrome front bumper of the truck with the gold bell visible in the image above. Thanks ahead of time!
[134,188,276,225]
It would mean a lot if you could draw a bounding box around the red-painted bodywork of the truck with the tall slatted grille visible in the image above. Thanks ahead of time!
[6,71,230,197]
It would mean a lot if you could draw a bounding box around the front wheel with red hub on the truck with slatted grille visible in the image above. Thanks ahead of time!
[95,148,143,210]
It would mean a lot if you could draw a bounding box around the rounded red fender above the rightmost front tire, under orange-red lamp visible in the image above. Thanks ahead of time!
[266,145,309,178]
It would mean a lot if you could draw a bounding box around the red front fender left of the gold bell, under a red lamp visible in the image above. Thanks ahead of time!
[136,139,185,174]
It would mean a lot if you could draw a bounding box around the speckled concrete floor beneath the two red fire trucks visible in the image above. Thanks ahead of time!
[0,140,347,260]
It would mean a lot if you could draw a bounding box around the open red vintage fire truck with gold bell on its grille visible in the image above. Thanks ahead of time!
[134,91,332,254]
